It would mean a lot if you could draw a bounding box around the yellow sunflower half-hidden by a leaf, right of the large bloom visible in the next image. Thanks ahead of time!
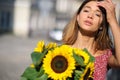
[74,48,90,65]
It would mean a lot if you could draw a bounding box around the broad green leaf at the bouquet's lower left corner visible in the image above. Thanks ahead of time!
[21,67,38,80]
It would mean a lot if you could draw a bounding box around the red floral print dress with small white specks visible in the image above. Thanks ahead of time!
[93,50,112,80]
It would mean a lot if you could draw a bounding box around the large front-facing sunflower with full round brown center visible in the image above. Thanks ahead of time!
[43,46,75,80]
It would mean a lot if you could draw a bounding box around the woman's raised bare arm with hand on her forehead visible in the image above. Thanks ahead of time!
[98,0,120,67]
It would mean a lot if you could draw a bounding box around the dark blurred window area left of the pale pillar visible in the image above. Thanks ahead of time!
[0,0,14,34]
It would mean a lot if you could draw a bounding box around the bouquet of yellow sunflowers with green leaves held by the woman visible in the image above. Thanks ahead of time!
[21,41,94,80]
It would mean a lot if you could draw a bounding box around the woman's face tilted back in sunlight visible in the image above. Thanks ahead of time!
[77,1,102,32]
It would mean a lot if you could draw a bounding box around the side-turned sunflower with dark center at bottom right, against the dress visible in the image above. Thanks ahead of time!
[79,62,94,80]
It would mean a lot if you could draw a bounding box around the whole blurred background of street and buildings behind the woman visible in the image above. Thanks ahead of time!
[0,0,120,80]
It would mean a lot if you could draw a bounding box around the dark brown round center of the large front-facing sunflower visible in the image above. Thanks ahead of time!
[51,55,68,73]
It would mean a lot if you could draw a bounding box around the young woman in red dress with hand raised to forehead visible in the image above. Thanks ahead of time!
[63,0,120,80]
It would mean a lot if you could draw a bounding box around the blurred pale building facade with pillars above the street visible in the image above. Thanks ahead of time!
[0,0,120,37]
